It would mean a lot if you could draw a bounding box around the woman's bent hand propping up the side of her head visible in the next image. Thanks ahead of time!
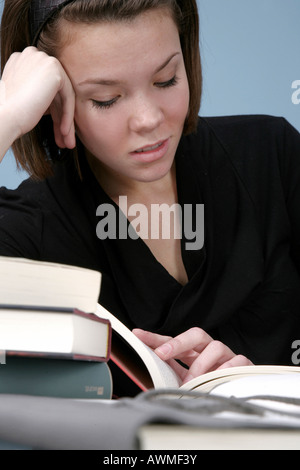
[0,47,75,148]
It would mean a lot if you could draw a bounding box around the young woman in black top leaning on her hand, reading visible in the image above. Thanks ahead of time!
[0,0,300,381]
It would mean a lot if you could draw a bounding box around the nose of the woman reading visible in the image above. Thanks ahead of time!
[129,95,164,133]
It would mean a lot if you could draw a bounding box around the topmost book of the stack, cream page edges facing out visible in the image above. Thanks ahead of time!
[0,256,102,312]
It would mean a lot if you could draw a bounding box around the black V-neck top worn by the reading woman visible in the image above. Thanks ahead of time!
[0,116,300,364]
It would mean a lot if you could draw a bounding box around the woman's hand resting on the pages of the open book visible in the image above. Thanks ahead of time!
[133,327,253,383]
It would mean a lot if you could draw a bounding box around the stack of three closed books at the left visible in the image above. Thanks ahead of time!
[0,257,112,399]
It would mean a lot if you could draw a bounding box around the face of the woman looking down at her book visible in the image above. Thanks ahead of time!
[58,10,189,189]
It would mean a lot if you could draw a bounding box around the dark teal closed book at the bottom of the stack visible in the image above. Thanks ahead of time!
[0,356,112,399]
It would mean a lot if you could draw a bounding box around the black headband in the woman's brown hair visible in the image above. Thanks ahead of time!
[29,0,73,46]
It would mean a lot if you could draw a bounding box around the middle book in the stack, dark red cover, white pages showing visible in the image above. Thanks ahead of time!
[0,306,111,361]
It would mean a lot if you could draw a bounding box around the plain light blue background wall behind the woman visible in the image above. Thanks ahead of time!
[0,0,300,188]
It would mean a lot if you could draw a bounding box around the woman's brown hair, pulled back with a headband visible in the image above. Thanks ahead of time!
[1,0,202,178]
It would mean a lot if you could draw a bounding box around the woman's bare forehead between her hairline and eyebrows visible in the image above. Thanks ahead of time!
[59,9,181,80]
